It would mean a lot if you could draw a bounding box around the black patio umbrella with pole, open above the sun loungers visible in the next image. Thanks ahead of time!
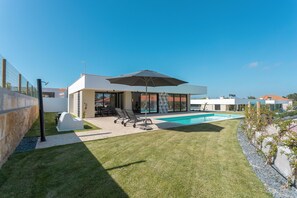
[107,70,187,130]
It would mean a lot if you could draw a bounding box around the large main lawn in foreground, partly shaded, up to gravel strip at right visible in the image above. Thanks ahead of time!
[0,120,271,198]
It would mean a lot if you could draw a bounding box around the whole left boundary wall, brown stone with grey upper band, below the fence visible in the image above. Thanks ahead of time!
[0,88,39,167]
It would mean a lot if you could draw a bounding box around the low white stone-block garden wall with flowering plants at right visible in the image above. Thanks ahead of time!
[242,104,297,186]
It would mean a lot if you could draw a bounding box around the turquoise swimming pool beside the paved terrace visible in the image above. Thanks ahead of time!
[157,113,244,125]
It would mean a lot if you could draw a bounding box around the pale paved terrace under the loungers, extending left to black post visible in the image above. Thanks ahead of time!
[36,112,205,149]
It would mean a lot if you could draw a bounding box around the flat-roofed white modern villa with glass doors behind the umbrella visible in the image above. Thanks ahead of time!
[68,74,207,117]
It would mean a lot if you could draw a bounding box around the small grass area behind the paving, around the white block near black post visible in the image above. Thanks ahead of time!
[26,113,99,137]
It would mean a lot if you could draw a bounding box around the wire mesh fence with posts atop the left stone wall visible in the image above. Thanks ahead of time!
[0,55,37,97]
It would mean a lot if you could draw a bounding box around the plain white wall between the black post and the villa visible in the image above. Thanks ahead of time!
[43,98,67,112]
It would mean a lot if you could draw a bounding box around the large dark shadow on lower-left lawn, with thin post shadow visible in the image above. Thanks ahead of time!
[0,143,130,198]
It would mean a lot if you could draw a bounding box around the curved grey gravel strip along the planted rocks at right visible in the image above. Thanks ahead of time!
[237,123,297,198]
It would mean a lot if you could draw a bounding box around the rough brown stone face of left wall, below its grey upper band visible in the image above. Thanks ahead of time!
[0,106,38,167]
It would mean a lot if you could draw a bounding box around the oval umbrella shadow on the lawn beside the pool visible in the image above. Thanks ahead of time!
[165,123,224,133]
